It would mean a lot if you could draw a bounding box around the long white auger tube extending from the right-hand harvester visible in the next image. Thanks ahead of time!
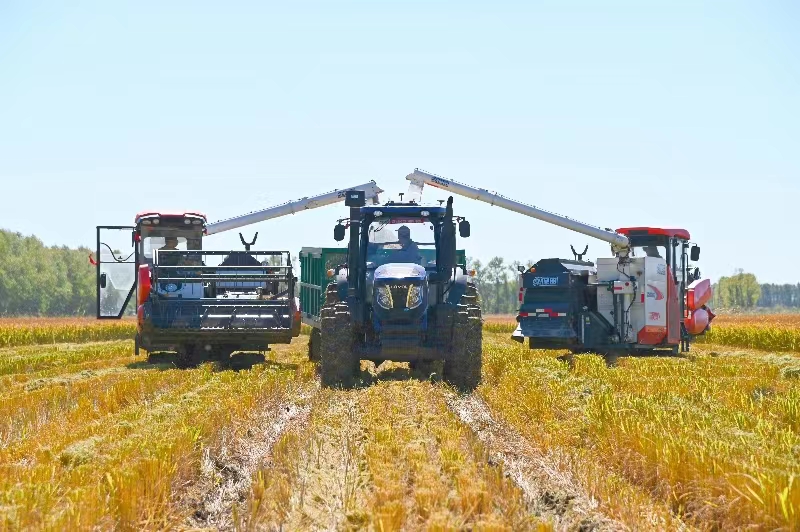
[406,168,630,252]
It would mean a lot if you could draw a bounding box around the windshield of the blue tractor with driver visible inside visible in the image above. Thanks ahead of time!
[367,218,436,267]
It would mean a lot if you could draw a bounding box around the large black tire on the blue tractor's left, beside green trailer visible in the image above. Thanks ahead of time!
[319,286,360,388]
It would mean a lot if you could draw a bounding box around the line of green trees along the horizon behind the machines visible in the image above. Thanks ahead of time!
[0,229,800,316]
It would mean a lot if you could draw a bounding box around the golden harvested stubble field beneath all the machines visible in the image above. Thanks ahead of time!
[0,317,800,530]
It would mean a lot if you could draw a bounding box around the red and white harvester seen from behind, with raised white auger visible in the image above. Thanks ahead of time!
[406,169,714,353]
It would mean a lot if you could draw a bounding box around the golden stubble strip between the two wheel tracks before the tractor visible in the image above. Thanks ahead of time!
[241,364,552,530]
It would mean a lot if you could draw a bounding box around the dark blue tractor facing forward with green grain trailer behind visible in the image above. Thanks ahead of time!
[301,192,481,389]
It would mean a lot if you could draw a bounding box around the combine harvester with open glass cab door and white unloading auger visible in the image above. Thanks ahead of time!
[95,182,381,366]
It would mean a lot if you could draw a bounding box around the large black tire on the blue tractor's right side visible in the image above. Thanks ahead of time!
[443,284,483,392]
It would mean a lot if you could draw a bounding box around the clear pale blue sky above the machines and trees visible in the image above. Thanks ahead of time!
[0,0,800,282]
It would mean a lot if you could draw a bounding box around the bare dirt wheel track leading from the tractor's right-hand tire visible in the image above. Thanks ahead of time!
[446,392,627,530]
